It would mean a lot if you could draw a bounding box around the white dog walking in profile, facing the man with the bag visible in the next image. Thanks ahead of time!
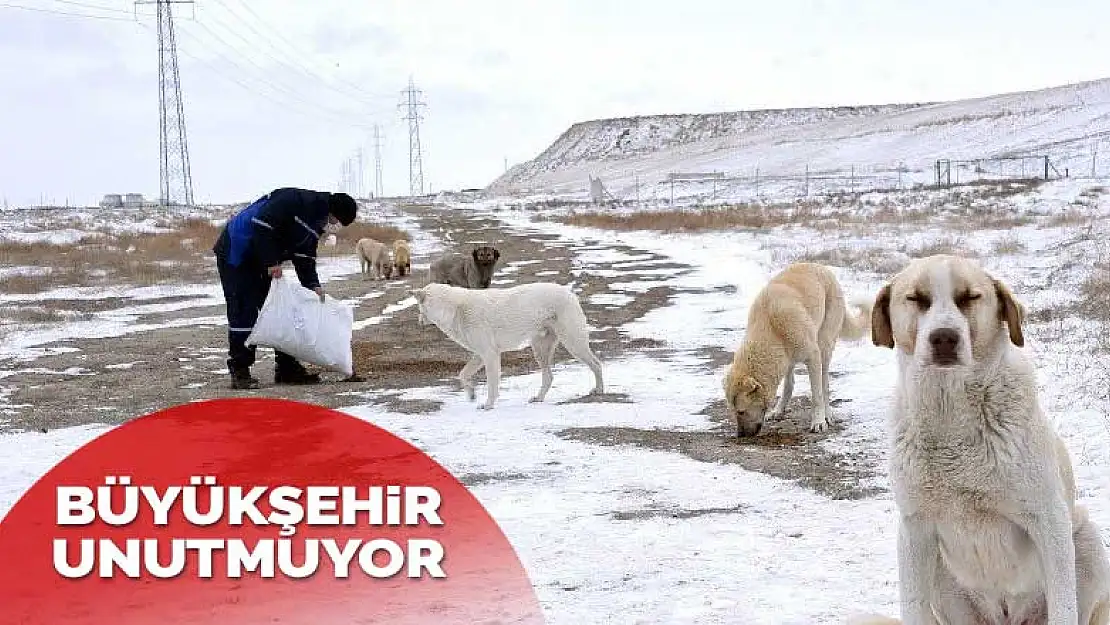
[410,282,605,410]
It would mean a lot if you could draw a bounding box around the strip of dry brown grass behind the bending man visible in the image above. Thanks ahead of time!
[0,219,410,294]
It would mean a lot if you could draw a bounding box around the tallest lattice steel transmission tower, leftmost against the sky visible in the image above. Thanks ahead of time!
[135,0,194,206]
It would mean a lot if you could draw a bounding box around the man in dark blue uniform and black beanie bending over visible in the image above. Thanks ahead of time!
[212,188,357,389]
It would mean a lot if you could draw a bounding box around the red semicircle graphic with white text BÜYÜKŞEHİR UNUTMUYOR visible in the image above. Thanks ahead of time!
[0,399,543,625]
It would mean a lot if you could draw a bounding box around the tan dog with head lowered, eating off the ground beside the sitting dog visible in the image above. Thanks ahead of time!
[723,263,871,437]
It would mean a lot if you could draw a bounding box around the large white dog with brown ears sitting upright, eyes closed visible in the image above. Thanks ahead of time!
[866,255,1110,625]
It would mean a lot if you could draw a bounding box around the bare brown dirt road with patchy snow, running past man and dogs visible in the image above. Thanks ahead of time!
[0,206,874,497]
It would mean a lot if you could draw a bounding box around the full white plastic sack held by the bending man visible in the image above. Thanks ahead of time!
[246,278,354,375]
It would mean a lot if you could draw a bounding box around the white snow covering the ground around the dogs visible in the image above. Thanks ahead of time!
[0,185,1110,625]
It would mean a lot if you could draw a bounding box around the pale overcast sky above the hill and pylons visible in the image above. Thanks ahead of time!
[0,0,1110,204]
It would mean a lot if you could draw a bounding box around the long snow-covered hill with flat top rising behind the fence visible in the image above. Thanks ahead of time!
[490,79,1110,199]
